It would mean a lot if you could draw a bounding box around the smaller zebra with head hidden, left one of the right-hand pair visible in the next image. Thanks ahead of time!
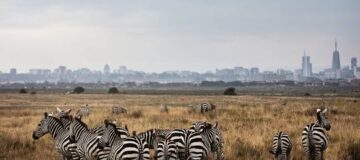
[270,132,292,160]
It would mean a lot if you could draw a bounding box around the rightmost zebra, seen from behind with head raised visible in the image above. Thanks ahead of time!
[301,109,331,160]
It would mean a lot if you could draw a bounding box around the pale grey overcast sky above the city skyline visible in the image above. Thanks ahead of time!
[0,0,360,72]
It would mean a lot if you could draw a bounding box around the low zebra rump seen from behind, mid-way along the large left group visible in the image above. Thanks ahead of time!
[155,136,178,160]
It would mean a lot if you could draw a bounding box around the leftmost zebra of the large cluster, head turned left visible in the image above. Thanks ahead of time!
[32,112,79,159]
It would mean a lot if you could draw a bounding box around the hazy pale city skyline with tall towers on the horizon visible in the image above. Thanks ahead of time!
[0,41,360,84]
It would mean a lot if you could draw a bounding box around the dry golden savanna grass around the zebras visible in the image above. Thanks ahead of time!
[0,94,360,160]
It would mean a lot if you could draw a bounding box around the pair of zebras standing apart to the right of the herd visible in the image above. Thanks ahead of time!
[270,109,331,160]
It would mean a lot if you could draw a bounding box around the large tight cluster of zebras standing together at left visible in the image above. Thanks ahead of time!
[32,108,224,160]
